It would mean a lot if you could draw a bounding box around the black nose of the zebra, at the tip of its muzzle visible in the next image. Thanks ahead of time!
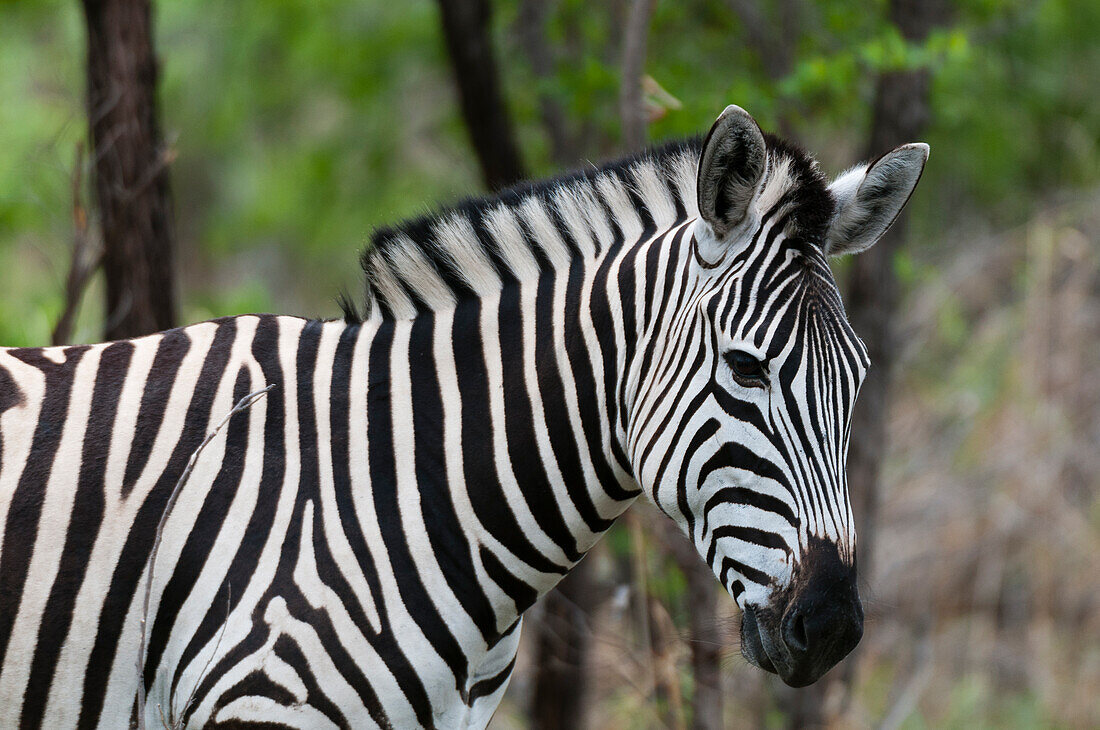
[780,545,864,687]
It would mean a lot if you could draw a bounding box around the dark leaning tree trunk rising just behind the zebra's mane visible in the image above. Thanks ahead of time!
[439,0,525,190]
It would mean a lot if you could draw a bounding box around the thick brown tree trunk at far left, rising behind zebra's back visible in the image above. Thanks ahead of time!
[83,0,176,340]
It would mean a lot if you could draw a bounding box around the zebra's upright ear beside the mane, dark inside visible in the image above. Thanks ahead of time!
[697,104,768,241]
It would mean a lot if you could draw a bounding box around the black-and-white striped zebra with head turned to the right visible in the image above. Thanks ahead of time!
[0,106,928,728]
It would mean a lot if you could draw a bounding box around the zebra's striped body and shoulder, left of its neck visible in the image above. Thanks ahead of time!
[0,316,558,728]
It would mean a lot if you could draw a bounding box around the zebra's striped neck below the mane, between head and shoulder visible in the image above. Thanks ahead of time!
[343,259,638,631]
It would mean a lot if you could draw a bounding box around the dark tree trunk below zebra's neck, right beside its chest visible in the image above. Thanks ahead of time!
[530,560,595,730]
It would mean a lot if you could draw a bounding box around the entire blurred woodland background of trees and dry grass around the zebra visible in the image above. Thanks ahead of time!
[0,0,1100,730]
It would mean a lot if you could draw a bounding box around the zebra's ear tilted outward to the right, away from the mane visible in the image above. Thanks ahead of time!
[825,142,928,256]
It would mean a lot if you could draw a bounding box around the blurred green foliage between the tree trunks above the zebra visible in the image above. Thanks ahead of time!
[0,0,1100,344]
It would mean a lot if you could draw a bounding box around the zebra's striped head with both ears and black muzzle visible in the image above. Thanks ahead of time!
[628,107,928,686]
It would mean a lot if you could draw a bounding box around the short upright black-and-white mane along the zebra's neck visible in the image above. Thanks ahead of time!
[341,139,700,322]
